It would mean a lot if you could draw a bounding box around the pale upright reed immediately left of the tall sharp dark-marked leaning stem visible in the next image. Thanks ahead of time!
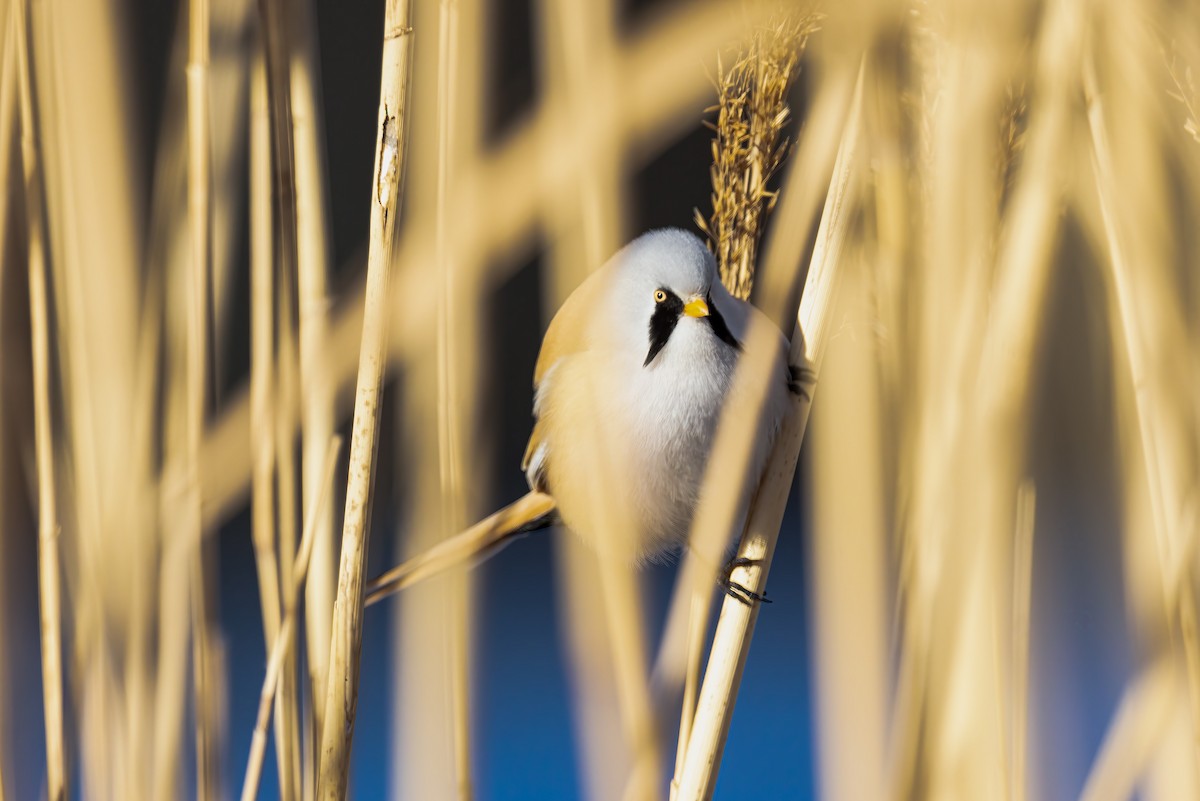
[292,0,335,763]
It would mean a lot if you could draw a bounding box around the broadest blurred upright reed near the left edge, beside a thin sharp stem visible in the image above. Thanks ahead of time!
[30,9,146,797]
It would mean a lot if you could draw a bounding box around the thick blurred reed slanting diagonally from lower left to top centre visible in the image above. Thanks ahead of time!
[203,0,791,520]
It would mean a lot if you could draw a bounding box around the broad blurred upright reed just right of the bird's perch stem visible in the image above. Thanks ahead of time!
[804,245,890,801]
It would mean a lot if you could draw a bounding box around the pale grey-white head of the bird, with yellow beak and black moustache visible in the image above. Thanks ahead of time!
[610,228,742,368]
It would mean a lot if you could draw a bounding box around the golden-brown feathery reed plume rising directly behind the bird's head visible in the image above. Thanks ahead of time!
[695,12,820,300]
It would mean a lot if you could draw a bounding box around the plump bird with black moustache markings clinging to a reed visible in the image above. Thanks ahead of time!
[521,228,799,573]
